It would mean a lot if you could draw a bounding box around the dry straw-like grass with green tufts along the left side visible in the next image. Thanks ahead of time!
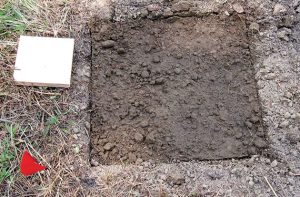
[0,0,89,196]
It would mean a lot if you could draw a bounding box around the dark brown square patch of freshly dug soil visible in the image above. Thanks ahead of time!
[91,16,267,164]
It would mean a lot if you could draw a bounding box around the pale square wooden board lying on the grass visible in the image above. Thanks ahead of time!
[14,36,74,87]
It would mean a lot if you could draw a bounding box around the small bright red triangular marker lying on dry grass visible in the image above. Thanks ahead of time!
[20,150,46,176]
